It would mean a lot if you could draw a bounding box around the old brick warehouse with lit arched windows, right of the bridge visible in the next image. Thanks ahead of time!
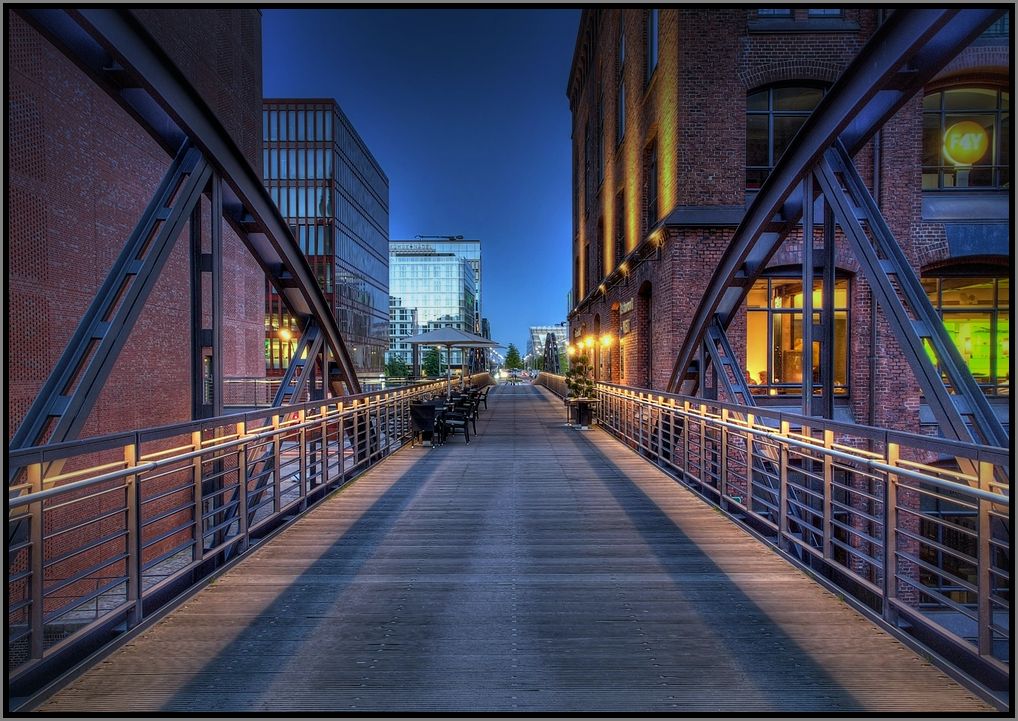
[567,7,1013,431]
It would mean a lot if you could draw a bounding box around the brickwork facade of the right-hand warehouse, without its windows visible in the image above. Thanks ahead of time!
[567,7,1011,431]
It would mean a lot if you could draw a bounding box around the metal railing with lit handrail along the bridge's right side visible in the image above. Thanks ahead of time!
[538,374,1012,688]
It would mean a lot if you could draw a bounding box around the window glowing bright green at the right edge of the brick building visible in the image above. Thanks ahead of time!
[922,275,1011,395]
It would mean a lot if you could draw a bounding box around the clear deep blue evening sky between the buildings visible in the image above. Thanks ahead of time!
[262,9,579,353]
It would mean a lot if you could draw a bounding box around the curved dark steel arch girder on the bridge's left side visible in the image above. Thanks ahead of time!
[16,8,360,411]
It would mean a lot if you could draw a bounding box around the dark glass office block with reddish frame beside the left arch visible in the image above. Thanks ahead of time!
[262,99,389,383]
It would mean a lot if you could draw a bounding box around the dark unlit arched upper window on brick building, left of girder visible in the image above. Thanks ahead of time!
[746,84,824,189]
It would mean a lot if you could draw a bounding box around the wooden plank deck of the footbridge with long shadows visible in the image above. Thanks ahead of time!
[38,385,993,714]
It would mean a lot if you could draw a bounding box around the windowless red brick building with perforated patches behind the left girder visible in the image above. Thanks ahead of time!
[6,8,265,438]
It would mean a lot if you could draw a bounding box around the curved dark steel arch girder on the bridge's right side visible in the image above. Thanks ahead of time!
[668,7,1006,440]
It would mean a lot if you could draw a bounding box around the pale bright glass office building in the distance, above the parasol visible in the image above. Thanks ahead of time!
[389,240,480,366]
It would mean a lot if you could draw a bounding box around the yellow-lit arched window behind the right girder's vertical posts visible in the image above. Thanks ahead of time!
[745,277,849,396]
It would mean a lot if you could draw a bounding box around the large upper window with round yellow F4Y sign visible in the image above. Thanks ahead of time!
[922,87,1011,190]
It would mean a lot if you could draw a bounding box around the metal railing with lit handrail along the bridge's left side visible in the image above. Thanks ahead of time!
[7,374,491,696]
